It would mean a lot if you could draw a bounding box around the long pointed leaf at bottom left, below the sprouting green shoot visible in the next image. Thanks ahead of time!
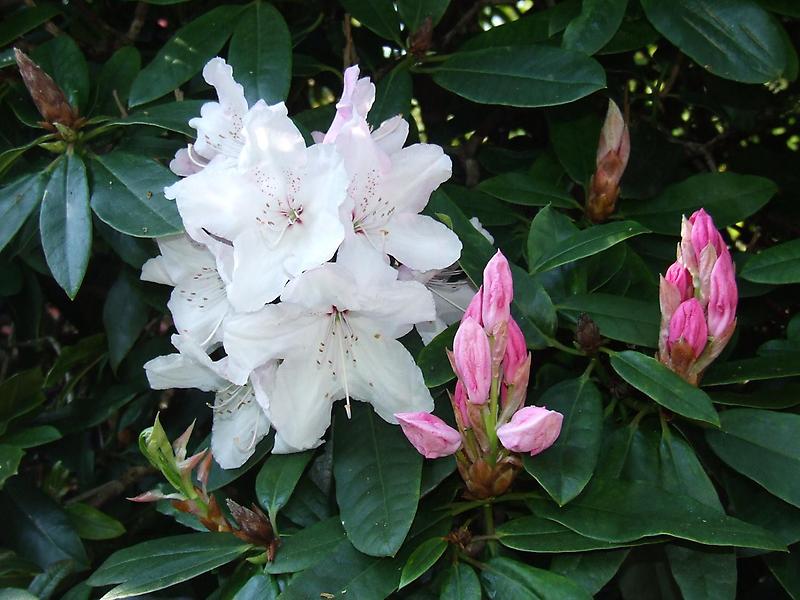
[88,533,250,600]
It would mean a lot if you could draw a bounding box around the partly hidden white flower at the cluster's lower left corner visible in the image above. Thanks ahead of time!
[144,335,276,469]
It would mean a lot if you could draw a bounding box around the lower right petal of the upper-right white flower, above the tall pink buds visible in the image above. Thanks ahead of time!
[385,214,461,271]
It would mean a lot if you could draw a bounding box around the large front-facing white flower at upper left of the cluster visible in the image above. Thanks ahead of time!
[165,103,347,311]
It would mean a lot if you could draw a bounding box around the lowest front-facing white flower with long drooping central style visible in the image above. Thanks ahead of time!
[224,248,435,452]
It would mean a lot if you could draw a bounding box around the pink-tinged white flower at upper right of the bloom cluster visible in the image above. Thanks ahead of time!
[316,67,461,271]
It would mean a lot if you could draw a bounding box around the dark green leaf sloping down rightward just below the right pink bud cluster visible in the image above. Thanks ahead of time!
[611,350,719,426]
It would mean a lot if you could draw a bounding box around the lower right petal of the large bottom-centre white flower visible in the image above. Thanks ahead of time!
[348,336,433,423]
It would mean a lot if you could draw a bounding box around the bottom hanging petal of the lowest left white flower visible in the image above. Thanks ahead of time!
[211,386,269,469]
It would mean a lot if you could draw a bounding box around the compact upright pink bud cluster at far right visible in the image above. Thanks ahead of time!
[658,208,739,385]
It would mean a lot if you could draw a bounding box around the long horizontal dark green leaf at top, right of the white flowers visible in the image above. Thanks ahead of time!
[433,46,606,107]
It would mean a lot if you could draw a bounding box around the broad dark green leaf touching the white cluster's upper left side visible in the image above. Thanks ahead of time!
[91,151,183,237]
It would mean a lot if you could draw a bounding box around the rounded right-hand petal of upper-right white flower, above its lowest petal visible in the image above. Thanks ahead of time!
[381,144,453,213]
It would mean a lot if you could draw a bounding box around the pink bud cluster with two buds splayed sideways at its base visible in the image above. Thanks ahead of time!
[395,251,563,498]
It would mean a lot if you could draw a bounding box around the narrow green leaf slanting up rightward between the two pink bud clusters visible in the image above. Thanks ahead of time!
[530,221,648,273]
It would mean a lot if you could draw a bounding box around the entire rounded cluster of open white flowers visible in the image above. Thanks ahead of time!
[142,58,472,468]
